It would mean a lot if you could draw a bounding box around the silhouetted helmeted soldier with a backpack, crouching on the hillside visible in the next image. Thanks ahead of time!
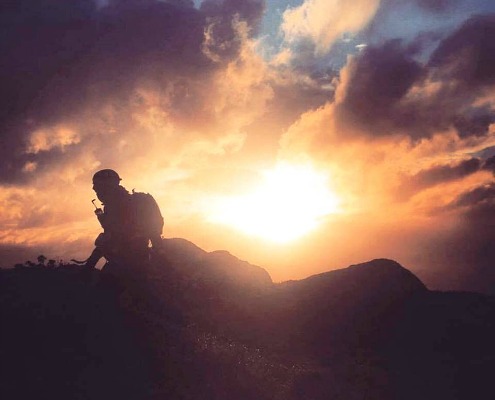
[85,169,163,268]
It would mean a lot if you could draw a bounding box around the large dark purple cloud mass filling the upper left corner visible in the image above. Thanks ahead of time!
[0,0,263,183]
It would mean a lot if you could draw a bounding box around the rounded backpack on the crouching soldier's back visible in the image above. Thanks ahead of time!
[131,190,163,239]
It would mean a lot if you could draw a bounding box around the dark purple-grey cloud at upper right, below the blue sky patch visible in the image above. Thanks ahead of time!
[339,15,495,139]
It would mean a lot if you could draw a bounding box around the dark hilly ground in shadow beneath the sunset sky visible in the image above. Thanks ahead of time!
[0,239,495,400]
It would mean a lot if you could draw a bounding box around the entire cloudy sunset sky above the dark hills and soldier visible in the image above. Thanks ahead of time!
[0,0,495,293]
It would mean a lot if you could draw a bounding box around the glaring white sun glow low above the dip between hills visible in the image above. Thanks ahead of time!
[211,163,340,243]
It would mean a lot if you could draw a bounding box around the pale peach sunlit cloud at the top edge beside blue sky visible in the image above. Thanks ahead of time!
[281,0,380,53]
